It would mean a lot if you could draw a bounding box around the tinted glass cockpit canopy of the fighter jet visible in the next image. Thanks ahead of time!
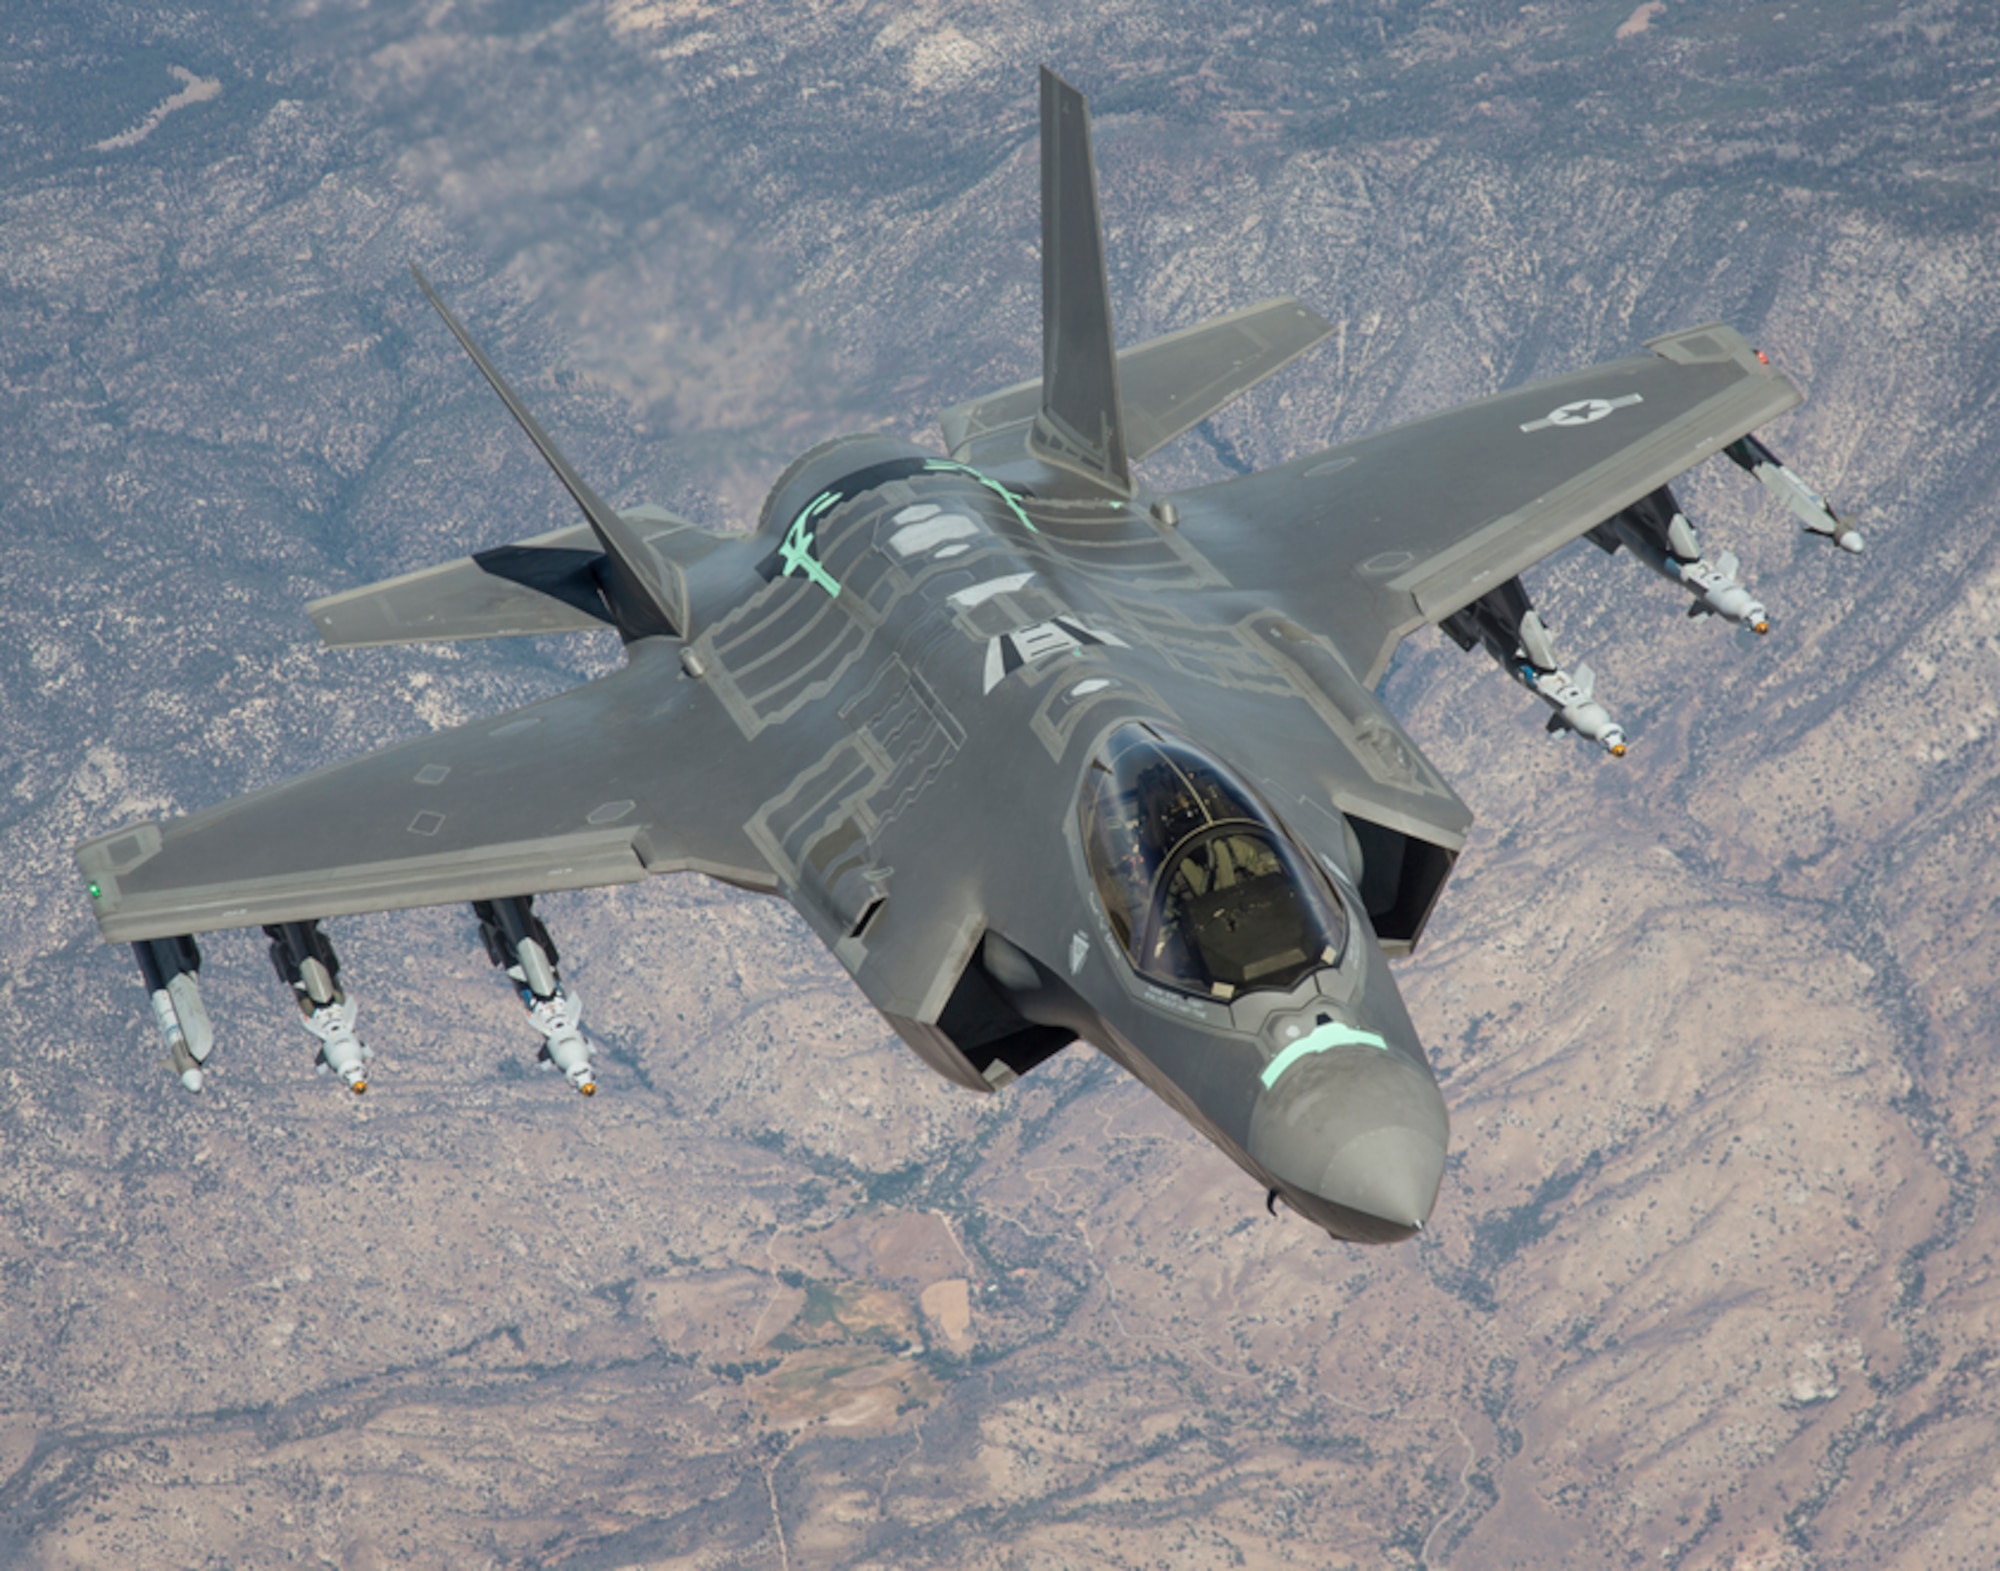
[1078,724,1348,999]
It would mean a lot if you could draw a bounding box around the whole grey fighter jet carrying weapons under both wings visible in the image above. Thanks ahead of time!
[76,70,1860,1243]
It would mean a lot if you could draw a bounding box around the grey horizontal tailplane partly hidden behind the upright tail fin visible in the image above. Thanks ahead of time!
[938,296,1332,464]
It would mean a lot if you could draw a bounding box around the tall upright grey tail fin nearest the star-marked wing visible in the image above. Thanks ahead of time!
[1028,66,1132,492]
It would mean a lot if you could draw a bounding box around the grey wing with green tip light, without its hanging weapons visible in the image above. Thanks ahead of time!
[76,650,776,941]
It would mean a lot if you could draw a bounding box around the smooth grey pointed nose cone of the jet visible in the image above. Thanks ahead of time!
[1250,1045,1450,1243]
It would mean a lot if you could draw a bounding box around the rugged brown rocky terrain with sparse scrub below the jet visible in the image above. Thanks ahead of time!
[0,0,2000,1571]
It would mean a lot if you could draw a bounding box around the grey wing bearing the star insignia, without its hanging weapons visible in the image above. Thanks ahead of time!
[1174,324,1800,686]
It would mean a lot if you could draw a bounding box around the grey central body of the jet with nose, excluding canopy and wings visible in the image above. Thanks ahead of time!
[668,438,1448,1241]
